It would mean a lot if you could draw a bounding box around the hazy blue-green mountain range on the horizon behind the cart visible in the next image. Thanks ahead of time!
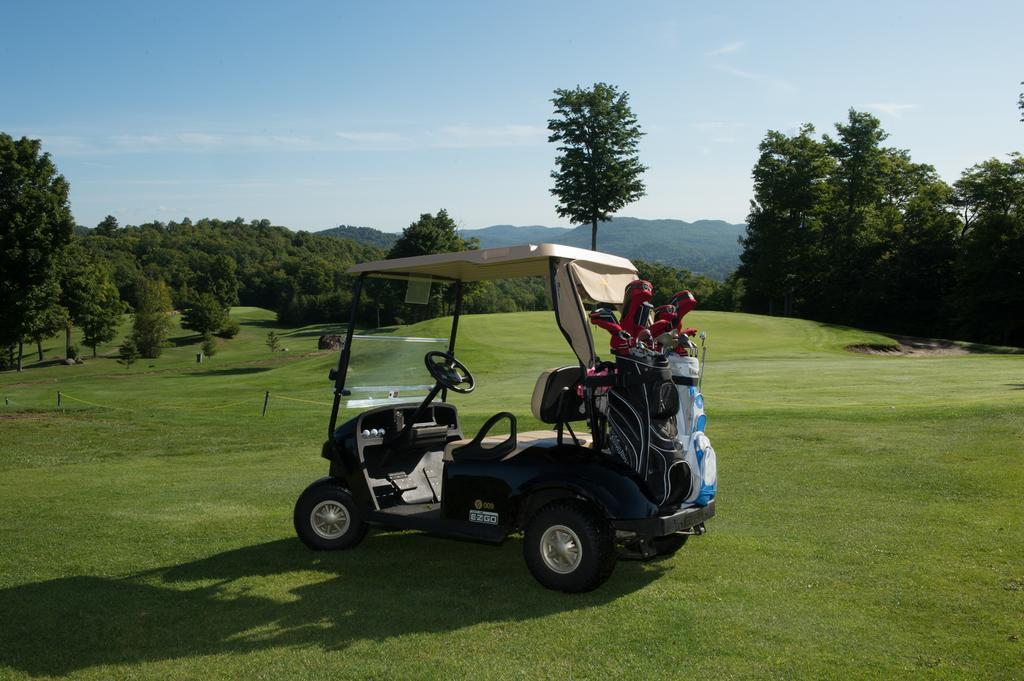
[316,217,746,280]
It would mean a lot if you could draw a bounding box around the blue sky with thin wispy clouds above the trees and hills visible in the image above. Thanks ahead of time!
[0,0,1024,230]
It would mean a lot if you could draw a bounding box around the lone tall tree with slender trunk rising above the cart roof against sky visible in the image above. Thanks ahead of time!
[548,83,647,251]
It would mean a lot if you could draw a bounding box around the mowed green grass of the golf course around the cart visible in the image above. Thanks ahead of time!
[0,308,1024,680]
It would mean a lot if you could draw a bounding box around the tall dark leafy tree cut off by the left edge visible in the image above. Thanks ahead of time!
[0,133,75,371]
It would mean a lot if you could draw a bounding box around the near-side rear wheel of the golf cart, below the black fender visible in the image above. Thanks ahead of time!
[522,501,616,593]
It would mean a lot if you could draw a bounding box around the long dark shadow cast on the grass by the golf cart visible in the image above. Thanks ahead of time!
[0,531,664,676]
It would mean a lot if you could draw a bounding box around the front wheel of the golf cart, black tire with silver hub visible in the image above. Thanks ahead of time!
[293,482,367,551]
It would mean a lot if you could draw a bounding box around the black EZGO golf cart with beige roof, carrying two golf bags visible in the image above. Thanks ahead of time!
[294,244,715,592]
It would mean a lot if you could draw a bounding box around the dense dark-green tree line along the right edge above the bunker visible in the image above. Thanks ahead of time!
[733,110,1024,345]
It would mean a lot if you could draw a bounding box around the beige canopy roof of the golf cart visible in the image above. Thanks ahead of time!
[348,244,637,304]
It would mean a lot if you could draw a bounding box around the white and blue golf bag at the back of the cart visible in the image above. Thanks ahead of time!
[669,353,718,506]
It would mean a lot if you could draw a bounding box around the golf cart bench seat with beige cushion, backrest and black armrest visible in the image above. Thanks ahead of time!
[444,365,593,461]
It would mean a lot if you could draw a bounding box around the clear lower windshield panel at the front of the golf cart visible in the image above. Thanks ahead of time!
[344,333,449,409]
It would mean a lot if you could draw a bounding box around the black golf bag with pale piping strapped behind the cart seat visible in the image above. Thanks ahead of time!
[608,356,690,506]
